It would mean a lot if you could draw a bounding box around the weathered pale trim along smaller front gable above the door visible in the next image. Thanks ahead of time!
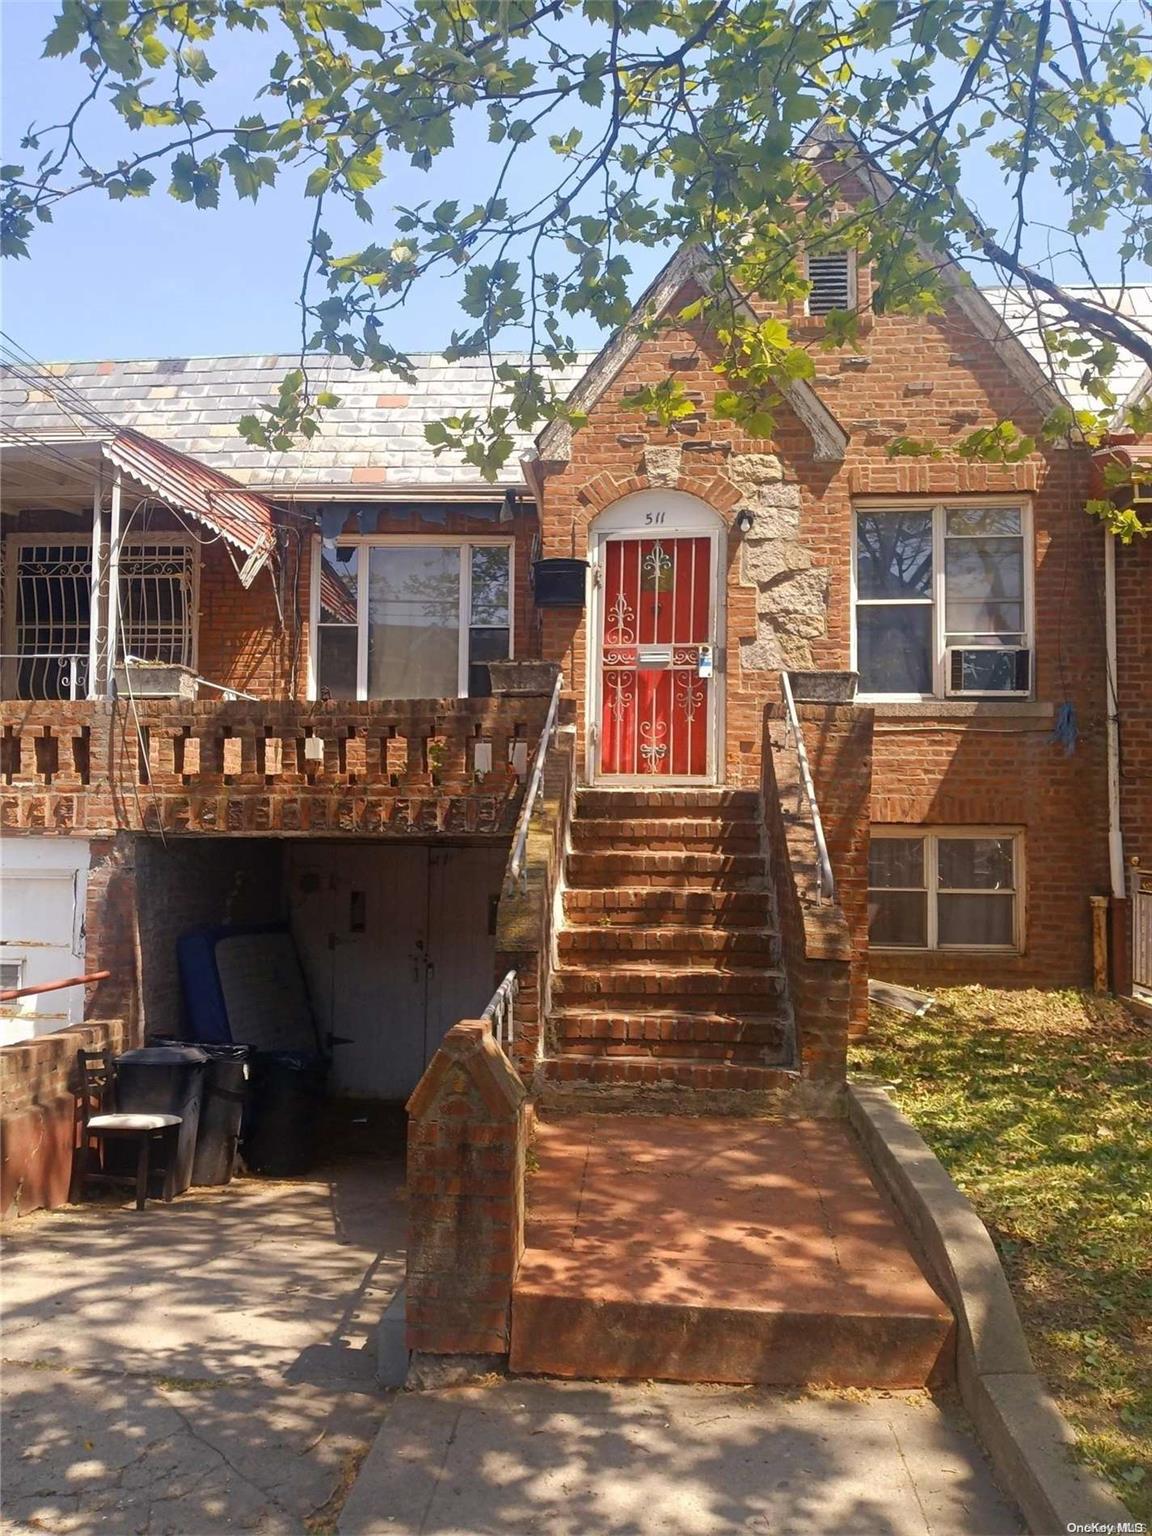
[535,246,848,462]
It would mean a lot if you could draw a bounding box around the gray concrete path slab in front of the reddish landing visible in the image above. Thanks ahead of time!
[338,1381,1021,1536]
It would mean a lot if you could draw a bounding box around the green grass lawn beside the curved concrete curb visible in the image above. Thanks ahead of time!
[852,986,1152,1525]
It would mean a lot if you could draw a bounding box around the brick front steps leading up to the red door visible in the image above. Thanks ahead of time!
[541,790,793,1103]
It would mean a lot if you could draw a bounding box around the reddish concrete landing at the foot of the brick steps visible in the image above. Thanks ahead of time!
[511,1115,952,1389]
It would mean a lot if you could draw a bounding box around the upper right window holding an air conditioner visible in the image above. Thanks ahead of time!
[854,502,1031,699]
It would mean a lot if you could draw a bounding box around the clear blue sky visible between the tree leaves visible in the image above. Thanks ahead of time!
[0,0,1138,359]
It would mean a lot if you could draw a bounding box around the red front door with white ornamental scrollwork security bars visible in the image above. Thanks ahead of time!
[599,536,714,779]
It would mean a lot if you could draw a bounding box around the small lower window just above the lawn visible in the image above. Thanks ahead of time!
[868,826,1020,949]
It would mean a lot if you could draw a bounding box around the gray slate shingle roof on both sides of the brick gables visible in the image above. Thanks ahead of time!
[9,284,1152,485]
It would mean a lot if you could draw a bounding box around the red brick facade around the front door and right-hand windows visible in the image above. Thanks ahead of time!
[531,248,1112,985]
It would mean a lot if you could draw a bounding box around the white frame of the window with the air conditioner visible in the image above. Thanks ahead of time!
[849,496,1035,703]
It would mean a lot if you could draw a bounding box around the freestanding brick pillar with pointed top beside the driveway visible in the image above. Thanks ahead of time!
[406,1018,530,1356]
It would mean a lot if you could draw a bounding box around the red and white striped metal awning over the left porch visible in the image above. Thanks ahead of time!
[101,427,276,587]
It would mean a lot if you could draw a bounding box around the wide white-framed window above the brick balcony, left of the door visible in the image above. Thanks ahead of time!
[312,538,513,699]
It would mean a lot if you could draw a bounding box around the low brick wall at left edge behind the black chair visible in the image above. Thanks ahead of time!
[0,1018,132,1217]
